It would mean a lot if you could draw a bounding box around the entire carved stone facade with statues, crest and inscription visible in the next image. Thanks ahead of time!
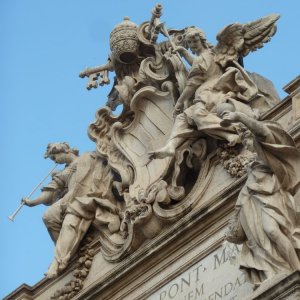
[7,4,300,300]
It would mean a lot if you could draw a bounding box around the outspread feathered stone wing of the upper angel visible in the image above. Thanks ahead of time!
[215,14,280,67]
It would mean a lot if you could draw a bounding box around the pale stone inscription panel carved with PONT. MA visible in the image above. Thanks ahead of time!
[148,244,252,300]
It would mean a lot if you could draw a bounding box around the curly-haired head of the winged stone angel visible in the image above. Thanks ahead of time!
[185,27,209,54]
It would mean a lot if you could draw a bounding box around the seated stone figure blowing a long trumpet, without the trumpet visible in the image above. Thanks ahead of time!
[22,143,120,278]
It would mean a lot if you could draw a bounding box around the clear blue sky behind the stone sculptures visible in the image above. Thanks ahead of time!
[0,0,300,298]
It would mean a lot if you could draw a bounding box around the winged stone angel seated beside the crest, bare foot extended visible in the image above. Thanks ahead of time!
[150,14,279,158]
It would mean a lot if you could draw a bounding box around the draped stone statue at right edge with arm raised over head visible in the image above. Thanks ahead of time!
[220,106,300,287]
